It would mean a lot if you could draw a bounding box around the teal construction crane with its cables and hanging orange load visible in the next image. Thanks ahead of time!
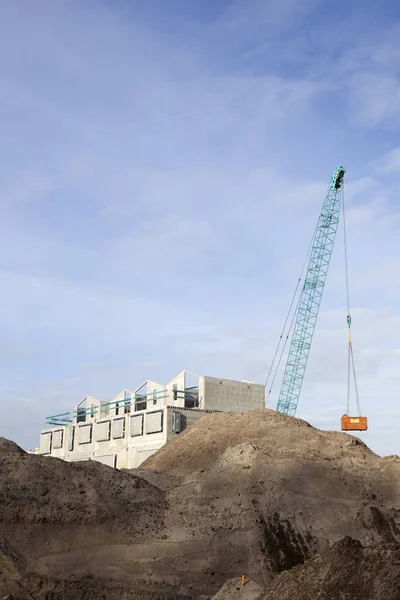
[266,166,367,431]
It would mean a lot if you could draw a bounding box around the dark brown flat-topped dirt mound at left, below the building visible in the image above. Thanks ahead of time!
[0,441,165,535]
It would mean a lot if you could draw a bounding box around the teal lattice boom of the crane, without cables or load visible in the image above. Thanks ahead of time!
[276,167,346,416]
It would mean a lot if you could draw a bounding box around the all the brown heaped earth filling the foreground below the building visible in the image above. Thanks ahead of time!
[0,410,400,600]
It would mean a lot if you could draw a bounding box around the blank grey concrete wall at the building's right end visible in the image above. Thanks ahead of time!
[204,377,265,412]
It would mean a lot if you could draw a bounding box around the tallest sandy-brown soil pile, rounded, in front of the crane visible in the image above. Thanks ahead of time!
[145,410,400,572]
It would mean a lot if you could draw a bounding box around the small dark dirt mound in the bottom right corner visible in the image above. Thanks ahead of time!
[260,537,400,600]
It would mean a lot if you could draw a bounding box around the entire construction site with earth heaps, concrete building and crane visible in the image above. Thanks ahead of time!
[0,167,400,600]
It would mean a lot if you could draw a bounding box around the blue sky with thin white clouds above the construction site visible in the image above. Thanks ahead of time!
[0,0,400,454]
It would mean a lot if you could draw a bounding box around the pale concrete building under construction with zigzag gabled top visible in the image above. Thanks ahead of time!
[38,371,265,469]
